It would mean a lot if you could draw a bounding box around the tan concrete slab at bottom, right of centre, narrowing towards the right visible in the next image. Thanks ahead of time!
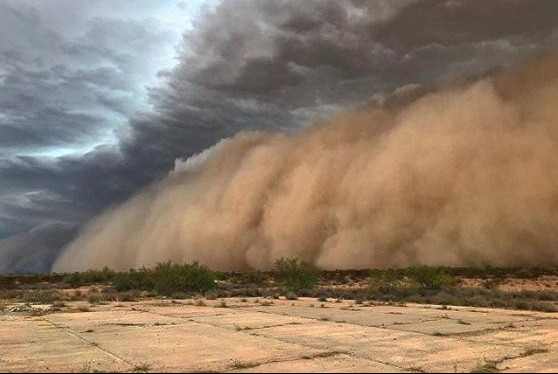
[249,322,521,372]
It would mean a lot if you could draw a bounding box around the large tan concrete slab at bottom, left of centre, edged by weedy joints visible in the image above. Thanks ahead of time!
[66,322,322,372]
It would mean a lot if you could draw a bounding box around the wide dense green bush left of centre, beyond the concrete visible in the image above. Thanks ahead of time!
[153,262,217,296]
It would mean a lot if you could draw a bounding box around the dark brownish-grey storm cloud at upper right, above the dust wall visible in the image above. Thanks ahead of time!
[165,0,558,125]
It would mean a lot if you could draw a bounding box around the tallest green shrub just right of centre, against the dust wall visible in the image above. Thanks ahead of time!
[275,258,318,293]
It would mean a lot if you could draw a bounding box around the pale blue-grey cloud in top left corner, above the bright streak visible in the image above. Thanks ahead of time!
[0,3,174,152]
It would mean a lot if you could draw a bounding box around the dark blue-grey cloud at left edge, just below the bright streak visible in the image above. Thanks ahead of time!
[0,147,140,225]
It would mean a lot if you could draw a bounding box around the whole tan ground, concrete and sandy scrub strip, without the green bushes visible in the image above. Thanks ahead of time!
[0,269,558,372]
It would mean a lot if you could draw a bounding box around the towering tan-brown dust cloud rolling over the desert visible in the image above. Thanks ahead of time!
[54,55,558,271]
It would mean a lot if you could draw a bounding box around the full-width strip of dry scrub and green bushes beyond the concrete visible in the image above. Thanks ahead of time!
[0,259,558,312]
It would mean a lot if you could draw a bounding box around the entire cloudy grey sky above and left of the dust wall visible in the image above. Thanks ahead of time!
[0,0,558,272]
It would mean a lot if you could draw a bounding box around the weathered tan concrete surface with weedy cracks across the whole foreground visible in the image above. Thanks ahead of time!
[0,299,558,372]
